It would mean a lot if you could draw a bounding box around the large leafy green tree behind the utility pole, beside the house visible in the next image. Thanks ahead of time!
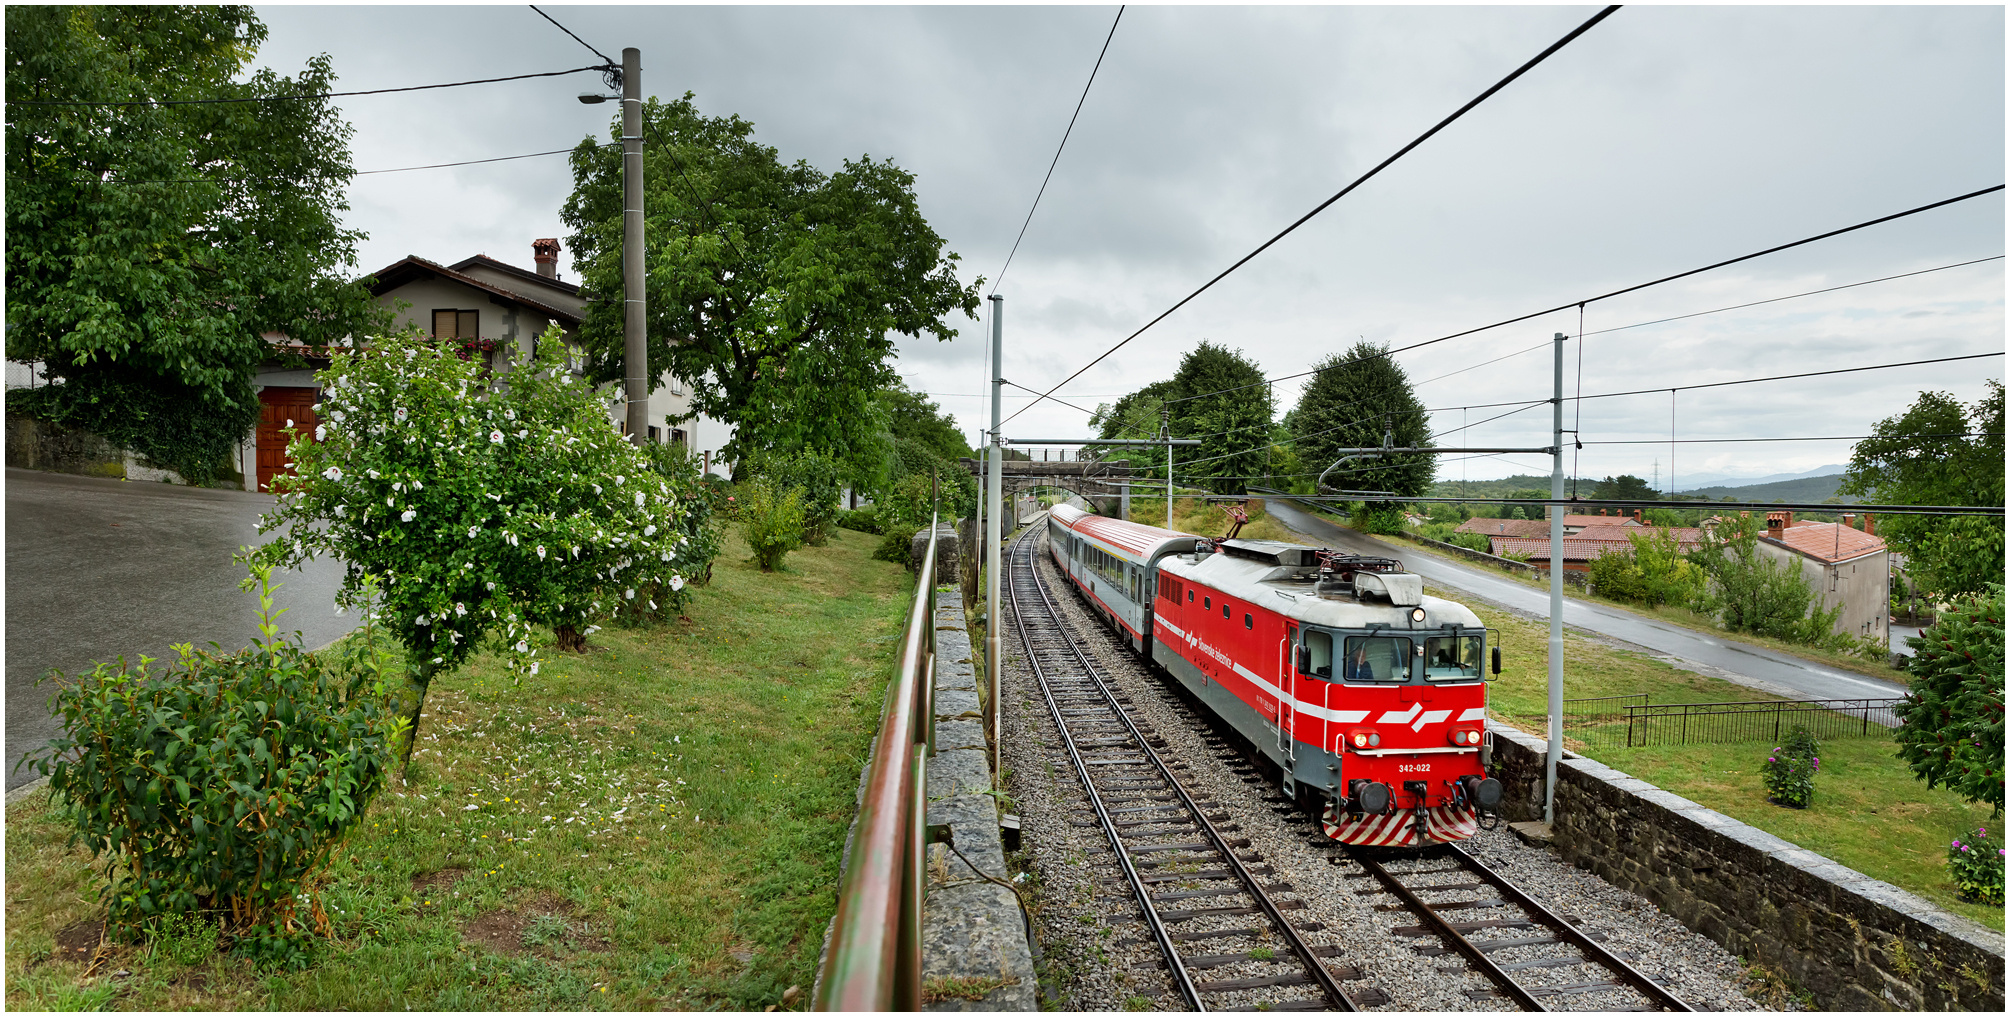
[561,92,983,484]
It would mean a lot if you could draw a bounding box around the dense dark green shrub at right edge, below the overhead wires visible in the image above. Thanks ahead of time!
[1893,583,2004,812]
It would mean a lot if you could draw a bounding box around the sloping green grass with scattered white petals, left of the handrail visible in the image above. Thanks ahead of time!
[6,531,911,1011]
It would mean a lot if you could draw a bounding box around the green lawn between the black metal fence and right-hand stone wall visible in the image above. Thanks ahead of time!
[1598,738,2004,931]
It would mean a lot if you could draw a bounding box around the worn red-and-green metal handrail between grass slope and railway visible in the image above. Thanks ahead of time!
[814,513,941,1011]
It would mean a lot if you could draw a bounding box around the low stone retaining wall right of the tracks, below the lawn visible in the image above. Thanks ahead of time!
[1489,724,2004,1013]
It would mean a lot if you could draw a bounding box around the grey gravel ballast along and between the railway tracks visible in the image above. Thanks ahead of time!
[1001,535,1763,1013]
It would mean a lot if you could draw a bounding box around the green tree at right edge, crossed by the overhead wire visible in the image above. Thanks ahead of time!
[1841,380,2004,599]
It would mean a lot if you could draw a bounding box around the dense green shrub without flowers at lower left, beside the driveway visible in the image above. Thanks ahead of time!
[30,569,404,944]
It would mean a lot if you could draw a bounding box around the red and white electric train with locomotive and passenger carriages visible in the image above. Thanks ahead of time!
[1047,504,1501,848]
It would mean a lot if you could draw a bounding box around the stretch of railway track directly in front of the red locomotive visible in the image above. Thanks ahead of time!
[1347,844,1692,1013]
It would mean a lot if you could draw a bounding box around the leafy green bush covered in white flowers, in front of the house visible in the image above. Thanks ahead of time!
[259,328,704,755]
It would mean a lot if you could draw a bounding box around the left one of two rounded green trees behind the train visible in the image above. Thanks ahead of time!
[1166,342,1276,494]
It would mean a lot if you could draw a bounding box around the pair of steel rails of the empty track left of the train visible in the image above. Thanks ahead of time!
[1011,527,1357,1011]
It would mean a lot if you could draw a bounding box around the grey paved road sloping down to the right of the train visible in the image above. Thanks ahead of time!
[1268,498,1905,699]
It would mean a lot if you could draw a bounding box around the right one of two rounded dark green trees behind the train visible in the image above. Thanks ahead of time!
[1290,342,1437,496]
